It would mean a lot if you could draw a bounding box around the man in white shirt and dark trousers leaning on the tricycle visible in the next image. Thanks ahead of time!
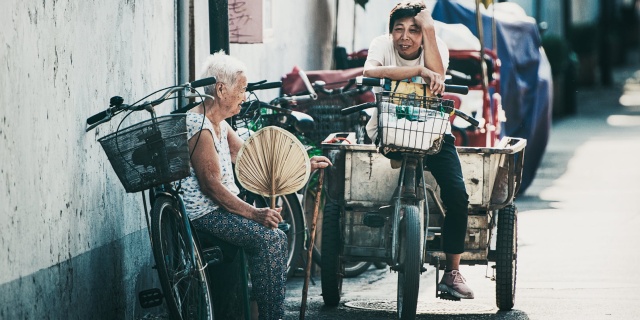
[364,0,474,299]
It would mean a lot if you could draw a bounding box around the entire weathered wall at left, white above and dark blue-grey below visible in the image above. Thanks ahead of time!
[0,0,175,319]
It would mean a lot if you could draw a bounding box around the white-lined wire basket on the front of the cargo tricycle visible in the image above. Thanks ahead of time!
[376,91,453,154]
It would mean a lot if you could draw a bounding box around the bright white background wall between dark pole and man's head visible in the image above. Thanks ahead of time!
[215,0,396,85]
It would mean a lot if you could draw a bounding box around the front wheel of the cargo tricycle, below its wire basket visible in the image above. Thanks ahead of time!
[397,205,423,320]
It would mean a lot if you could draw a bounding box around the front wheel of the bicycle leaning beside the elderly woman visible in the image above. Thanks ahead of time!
[151,197,214,320]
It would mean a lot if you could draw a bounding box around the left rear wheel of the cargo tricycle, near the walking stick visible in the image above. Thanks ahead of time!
[320,201,344,307]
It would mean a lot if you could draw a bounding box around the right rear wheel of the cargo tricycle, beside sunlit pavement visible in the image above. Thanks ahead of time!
[496,204,518,310]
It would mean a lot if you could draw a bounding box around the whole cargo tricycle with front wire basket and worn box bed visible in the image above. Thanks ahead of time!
[321,78,526,319]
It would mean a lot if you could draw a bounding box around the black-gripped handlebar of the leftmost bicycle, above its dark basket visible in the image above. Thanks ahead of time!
[85,77,216,132]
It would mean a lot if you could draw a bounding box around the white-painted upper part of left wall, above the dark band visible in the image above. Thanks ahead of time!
[0,0,175,282]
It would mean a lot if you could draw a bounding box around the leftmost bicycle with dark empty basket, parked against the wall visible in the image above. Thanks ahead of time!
[86,78,222,319]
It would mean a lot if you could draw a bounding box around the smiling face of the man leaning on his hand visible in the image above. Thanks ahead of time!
[391,17,422,60]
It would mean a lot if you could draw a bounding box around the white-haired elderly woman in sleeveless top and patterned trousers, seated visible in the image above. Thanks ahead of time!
[183,52,331,320]
